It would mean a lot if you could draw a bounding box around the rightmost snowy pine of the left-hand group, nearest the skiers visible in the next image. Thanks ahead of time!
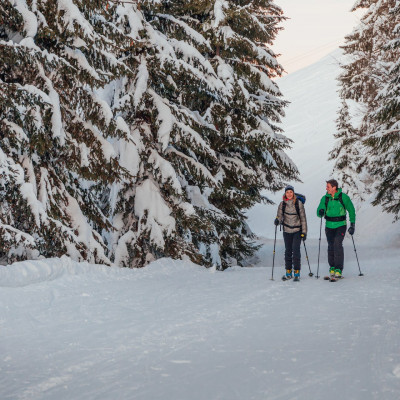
[203,0,297,268]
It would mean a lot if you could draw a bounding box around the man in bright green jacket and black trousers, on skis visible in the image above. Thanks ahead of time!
[317,179,356,278]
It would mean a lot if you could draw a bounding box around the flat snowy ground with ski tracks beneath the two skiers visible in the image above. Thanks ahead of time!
[0,240,400,400]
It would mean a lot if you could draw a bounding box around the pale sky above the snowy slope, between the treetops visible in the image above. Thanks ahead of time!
[272,0,362,73]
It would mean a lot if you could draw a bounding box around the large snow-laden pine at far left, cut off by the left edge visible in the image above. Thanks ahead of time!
[0,0,131,263]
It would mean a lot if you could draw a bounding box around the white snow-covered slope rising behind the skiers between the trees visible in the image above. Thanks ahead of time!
[248,50,400,245]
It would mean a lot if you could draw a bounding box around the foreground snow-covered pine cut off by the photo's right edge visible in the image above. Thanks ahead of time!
[365,1,400,220]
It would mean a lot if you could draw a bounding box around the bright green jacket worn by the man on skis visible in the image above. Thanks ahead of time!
[317,189,356,229]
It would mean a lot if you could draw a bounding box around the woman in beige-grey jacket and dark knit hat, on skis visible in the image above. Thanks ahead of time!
[274,185,307,280]
